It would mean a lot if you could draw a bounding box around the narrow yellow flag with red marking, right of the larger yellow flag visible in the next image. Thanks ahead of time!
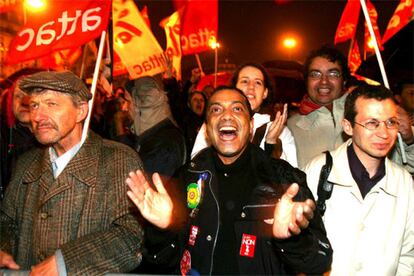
[160,11,181,80]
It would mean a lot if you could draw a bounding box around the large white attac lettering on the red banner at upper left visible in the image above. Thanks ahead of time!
[16,7,102,51]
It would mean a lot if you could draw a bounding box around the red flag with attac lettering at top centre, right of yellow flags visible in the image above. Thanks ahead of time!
[181,0,218,55]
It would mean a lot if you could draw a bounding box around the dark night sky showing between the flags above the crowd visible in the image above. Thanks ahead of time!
[136,0,399,74]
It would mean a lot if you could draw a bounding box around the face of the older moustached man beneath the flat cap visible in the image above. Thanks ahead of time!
[30,90,88,156]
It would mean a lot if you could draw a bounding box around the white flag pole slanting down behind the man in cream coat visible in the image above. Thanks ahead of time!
[360,0,407,164]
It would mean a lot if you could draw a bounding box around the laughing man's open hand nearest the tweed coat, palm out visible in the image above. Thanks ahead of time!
[125,170,173,229]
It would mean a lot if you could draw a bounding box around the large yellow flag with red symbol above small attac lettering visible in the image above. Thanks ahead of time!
[112,0,165,79]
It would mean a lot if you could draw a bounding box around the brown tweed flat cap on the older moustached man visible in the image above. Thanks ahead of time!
[19,71,92,101]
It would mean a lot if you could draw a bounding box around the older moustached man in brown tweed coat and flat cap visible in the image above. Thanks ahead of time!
[0,71,146,275]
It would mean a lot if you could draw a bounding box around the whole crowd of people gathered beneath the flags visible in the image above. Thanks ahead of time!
[0,46,414,275]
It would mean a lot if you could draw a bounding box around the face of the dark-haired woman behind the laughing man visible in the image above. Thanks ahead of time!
[236,66,268,111]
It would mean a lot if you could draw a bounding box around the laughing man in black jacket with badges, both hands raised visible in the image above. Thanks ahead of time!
[126,88,332,275]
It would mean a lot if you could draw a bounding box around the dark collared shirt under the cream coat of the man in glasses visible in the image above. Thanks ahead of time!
[347,144,385,198]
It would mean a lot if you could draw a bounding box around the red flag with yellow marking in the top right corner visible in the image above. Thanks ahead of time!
[382,0,414,43]
